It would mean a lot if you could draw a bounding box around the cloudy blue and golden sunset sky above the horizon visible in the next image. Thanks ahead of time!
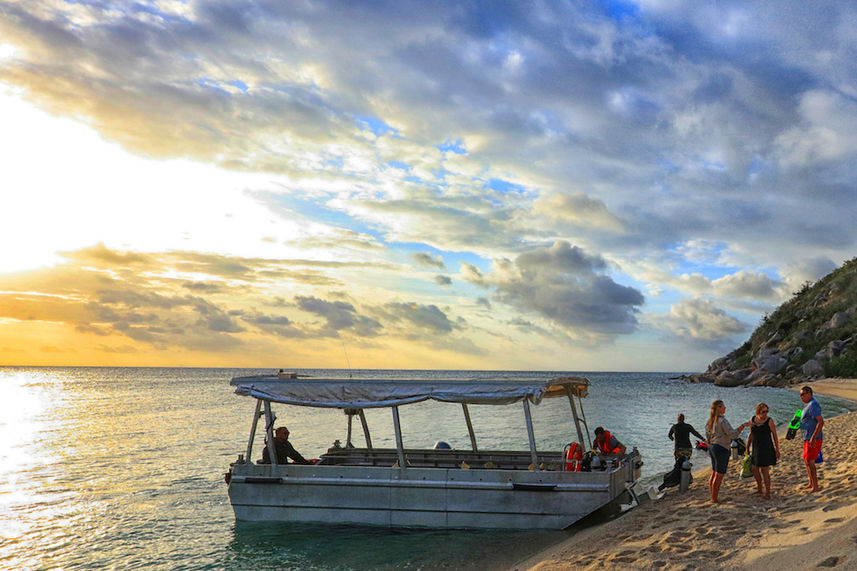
[0,0,857,372]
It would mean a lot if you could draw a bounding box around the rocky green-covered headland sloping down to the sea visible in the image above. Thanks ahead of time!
[685,258,857,387]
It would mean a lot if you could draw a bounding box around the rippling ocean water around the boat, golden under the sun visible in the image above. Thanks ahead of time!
[0,367,857,570]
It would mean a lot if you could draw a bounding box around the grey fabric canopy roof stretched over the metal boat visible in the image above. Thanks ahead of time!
[231,375,589,409]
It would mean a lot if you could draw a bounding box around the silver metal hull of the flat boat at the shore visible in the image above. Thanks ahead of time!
[229,462,635,529]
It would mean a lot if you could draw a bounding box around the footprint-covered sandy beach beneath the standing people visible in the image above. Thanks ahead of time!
[512,379,857,571]
